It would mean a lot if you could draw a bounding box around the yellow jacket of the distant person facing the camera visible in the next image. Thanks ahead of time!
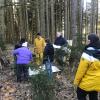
[34,37,45,54]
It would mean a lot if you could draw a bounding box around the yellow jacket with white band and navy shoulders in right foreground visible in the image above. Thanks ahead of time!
[74,42,100,91]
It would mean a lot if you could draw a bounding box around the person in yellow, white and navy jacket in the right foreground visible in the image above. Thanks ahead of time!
[74,33,100,100]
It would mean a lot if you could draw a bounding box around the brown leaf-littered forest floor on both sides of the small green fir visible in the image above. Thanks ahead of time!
[0,45,77,100]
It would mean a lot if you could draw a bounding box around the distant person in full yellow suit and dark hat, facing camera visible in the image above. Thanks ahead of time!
[34,33,45,65]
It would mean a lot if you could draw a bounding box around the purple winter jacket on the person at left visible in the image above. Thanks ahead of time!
[13,47,32,64]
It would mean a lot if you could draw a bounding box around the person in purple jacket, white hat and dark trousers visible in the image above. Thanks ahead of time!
[13,42,32,82]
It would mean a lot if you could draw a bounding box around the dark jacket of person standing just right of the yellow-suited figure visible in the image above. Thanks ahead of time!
[43,43,54,63]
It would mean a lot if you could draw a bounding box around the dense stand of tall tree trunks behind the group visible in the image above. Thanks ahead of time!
[0,0,100,45]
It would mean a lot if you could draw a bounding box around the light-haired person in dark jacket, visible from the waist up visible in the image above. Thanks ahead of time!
[54,32,67,46]
